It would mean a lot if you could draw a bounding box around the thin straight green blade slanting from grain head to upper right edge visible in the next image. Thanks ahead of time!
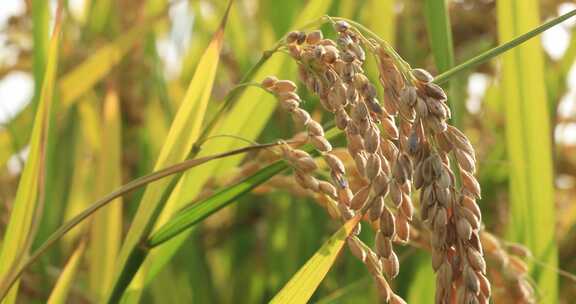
[434,9,576,83]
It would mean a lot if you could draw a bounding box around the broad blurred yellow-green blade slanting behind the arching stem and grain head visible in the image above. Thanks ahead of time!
[138,0,332,289]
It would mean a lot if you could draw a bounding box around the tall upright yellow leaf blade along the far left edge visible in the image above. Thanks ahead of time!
[0,10,61,303]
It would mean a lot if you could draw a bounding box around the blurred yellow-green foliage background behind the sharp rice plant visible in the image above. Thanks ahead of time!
[0,0,576,303]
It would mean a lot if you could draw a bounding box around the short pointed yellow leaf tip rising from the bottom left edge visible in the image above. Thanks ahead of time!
[47,241,86,304]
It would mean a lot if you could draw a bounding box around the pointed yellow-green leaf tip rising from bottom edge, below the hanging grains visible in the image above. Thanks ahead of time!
[270,216,360,304]
